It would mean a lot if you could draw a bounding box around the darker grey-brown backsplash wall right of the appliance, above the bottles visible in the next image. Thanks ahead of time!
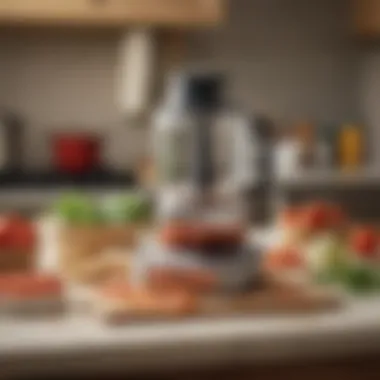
[190,0,358,121]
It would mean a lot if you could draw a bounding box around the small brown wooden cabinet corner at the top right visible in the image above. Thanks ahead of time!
[352,0,380,37]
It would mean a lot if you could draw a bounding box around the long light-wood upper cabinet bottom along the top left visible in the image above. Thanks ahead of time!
[0,0,225,27]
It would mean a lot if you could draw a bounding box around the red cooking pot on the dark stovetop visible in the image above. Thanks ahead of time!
[53,134,100,174]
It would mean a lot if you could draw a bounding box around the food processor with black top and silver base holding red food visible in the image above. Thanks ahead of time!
[132,73,260,293]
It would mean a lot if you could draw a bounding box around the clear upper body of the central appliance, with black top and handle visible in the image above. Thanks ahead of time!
[154,72,271,223]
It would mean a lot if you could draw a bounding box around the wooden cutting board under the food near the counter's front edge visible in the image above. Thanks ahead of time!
[96,278,342,324]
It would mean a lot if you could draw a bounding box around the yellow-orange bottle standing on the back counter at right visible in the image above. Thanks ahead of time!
[338,124,363,170]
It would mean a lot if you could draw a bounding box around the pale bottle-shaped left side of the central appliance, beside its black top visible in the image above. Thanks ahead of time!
[153,74,192,221]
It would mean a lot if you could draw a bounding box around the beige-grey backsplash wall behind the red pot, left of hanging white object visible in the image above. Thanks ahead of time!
[0,32,145,167]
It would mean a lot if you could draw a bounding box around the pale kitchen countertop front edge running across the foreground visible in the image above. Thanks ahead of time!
[0,230,380,376]
